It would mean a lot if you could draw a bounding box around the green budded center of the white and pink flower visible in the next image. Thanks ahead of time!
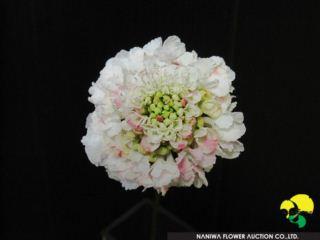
[121,86,219,163]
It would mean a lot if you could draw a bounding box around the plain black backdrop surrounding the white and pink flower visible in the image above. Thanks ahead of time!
[0,0,320,239]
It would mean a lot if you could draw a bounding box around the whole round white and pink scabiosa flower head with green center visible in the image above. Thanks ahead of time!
[82,36,246,195]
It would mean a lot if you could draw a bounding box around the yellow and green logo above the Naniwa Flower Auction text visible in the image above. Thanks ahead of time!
[280,194,314,228]
